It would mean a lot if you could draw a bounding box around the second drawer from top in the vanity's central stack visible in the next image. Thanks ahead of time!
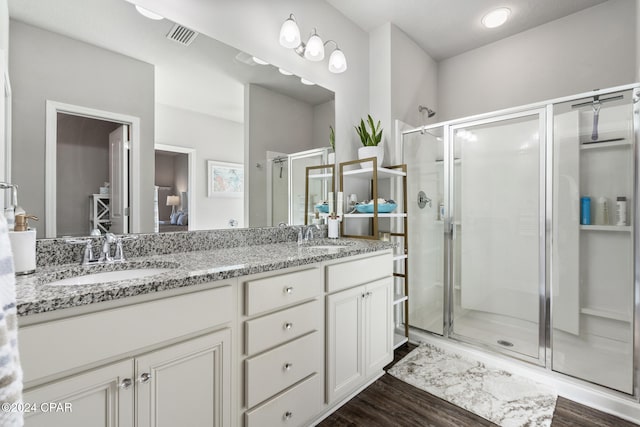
[245,300,324,355]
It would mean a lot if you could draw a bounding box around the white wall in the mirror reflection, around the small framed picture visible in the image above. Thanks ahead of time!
[156,104,244,230]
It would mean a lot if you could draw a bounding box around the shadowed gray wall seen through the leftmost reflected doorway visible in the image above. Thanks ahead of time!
[56,114,120,236]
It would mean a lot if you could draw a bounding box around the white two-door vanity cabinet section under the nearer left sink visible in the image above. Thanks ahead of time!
[19,285,234,427]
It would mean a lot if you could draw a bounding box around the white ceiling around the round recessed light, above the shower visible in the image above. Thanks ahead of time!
[326,0,607,61]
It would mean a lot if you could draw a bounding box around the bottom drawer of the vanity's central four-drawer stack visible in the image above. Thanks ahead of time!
[245,374,322,427]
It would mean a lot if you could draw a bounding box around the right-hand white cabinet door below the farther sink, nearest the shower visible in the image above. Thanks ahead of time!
[364,277,393,376]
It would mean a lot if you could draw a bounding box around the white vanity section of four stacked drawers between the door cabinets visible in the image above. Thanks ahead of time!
[240,265,324,427]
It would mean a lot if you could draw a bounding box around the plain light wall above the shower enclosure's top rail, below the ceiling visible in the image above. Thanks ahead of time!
[438,0,637,121]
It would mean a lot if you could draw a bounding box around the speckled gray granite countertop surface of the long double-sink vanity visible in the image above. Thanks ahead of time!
[16,239,396,316]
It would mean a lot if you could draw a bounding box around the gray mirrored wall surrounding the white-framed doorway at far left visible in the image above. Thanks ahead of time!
[9,20,154,237]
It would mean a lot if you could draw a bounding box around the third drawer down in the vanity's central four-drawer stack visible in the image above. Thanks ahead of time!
[245,332,323,408]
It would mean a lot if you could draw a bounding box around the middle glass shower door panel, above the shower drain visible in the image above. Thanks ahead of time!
[445,109,545,364]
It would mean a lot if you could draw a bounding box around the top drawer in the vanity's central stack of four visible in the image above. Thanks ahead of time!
[245,268,322,316]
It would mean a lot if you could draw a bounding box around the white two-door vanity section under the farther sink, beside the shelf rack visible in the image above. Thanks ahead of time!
[326,253,393,404]
